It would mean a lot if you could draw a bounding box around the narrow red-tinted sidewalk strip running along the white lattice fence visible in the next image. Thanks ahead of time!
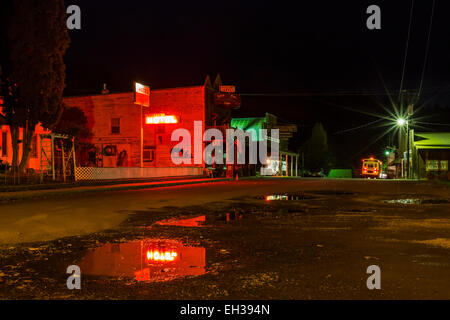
[0,177,232,202]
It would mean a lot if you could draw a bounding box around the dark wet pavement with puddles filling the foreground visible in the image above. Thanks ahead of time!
[0,179,450,299]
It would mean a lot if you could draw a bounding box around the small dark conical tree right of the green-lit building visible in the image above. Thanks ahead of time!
[300,123,333,171]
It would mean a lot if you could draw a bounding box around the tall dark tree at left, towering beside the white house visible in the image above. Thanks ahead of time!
[2,0,70,171]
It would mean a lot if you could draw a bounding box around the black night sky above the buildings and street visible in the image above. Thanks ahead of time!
[65,0,450,166]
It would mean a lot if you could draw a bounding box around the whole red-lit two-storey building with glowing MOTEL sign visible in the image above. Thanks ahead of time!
[64,77,237,172]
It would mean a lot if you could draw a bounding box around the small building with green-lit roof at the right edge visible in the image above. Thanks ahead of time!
[411,132,450,180]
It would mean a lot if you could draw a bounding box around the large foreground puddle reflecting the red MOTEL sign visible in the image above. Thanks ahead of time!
[79,239,206,282]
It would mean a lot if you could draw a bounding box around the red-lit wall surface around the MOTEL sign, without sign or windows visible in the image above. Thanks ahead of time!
[64,86,206,167]
